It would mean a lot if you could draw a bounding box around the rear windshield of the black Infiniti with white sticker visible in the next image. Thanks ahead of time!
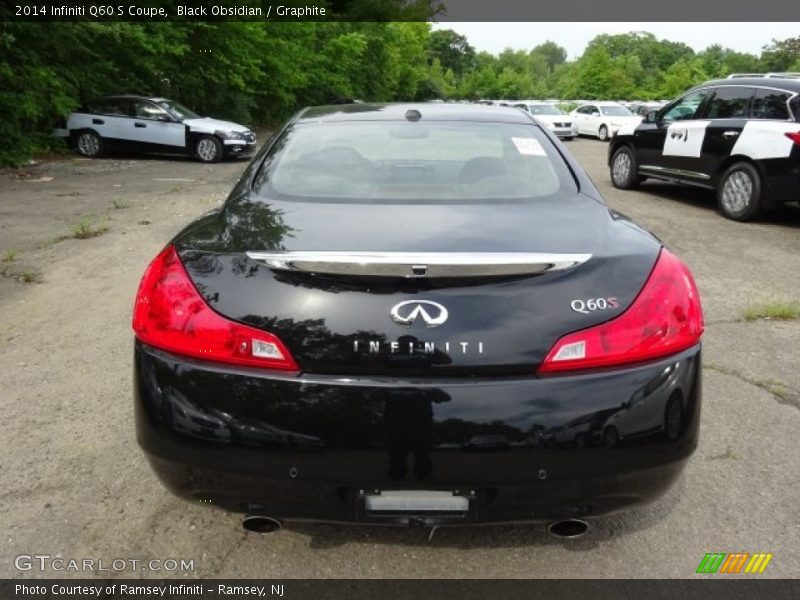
[255,121,576,202]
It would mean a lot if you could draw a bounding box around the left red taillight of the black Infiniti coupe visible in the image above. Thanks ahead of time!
[133,246,299,371]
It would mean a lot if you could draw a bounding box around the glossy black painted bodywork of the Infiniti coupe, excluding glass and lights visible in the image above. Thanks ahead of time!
[134,104,701,524]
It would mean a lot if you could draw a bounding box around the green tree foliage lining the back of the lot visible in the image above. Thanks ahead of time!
[0,20,800,164]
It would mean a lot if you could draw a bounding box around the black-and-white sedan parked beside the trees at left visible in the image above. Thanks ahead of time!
[64,95,256,163]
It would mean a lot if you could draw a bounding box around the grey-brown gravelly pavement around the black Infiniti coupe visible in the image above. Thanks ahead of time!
[0,140,800,578]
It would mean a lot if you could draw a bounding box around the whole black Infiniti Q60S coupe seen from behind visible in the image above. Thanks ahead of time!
[133,104,703,532]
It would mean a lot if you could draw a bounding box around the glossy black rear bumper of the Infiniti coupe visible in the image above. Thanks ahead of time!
[134,343,701,524]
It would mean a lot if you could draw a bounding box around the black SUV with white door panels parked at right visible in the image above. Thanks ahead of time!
[608,73,800,221]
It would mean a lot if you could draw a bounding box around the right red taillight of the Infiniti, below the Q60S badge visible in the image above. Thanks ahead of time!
[539,249,703,373]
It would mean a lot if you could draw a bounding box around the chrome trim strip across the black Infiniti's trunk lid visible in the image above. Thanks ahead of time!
[246,250,592,278]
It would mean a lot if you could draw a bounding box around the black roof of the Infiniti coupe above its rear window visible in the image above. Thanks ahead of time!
[297,102,532,125]
